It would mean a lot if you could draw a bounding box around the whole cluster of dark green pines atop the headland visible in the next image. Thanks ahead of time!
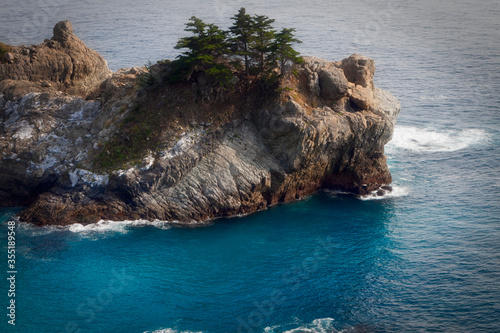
[166,8,302,97]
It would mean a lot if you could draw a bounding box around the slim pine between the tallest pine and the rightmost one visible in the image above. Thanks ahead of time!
[251,15,276,73]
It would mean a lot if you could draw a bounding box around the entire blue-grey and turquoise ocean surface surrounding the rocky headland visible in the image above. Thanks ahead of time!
[0,0,500,333]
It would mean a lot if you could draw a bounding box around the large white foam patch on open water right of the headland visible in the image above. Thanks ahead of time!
[386,126,490,154]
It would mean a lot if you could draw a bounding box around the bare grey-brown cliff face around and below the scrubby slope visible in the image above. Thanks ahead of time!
[0,21,400,225]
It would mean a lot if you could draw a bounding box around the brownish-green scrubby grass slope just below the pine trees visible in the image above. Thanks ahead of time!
[94,76,276,171]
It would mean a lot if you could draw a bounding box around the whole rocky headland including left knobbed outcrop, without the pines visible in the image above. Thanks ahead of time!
[0,21,400,225]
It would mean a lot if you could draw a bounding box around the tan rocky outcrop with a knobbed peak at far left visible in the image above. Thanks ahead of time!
[0,21,111,98]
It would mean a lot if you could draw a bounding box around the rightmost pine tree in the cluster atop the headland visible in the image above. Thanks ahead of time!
[271,28,304,76]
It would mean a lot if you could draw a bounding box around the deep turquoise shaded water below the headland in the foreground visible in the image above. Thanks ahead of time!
[0,192,401,332]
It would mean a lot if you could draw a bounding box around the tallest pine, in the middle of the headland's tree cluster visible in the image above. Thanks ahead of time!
[229,7,254,76]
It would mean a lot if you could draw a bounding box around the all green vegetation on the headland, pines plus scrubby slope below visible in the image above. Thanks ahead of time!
[94,8,303,171]
